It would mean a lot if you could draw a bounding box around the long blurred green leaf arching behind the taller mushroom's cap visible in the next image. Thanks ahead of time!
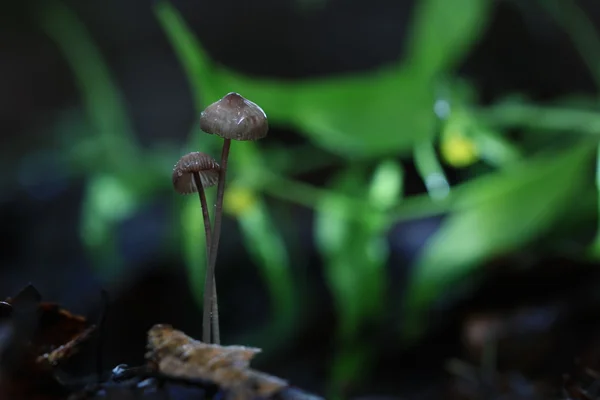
[155,0,492,157]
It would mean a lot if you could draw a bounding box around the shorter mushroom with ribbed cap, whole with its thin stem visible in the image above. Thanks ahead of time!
[173,152,220,343]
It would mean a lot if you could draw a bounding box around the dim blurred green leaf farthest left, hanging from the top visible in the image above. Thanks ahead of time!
[35,0,159,279]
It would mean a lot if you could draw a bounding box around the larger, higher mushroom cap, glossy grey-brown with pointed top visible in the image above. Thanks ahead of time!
[200,92,269,140]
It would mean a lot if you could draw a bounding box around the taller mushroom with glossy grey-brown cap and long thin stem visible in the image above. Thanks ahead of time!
[200,92,269,344]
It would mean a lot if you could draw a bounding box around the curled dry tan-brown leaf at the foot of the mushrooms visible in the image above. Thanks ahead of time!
[146,325,288,400]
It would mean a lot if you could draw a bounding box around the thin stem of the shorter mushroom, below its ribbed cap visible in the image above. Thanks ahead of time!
[193,172,220,343]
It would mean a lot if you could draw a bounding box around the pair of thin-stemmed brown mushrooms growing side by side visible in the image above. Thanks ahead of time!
[173,92,269,344]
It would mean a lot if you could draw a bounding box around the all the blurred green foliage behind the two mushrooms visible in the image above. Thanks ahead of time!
[36,0,600,398]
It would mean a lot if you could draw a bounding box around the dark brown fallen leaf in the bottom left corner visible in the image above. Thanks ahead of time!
[0,285,95,400]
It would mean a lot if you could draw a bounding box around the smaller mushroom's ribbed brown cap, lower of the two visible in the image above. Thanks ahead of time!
[173,152,220,194]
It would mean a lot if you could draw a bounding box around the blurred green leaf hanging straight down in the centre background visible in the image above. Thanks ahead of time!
[315,169,387,341]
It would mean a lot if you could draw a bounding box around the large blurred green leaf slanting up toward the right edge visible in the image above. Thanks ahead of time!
[406,143,594,337]
